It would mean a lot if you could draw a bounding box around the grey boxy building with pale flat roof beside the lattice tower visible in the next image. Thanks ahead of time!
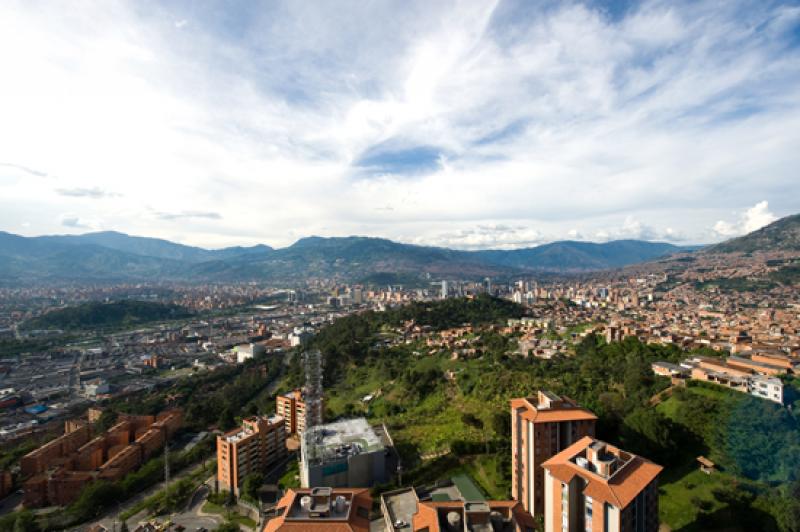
[300,418,386,487]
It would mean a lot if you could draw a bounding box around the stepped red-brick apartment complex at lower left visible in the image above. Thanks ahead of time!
[20,410,182,508]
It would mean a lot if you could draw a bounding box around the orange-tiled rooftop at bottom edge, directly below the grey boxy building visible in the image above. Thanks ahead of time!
[263,488,372,532]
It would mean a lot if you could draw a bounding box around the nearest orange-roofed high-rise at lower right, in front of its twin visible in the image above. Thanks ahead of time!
[542,437,663,532]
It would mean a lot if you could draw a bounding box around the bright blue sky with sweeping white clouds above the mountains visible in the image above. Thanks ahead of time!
[0,0,800,249]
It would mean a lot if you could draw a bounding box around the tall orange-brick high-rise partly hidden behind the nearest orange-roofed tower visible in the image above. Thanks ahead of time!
[511,391,597,516]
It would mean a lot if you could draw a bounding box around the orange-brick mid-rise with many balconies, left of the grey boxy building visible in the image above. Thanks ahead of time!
[217,416,287,494]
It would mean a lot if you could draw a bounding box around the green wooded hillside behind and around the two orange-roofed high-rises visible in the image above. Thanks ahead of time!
[285,297,800,530]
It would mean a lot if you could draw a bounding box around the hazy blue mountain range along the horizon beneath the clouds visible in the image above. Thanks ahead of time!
[0,215,800,285]
